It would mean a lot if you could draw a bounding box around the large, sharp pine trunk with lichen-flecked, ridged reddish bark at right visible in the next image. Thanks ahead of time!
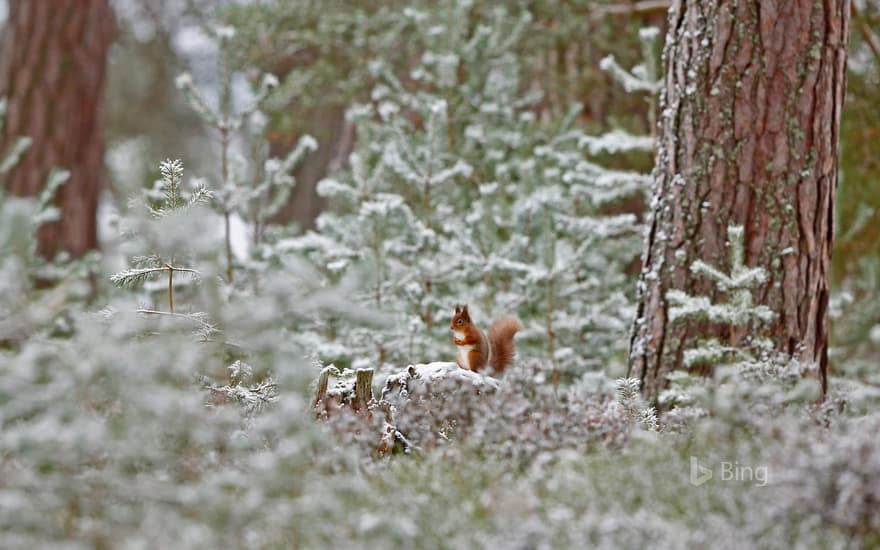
[630,0,850,397]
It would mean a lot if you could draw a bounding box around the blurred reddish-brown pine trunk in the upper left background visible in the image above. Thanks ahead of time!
[0,0,113,258]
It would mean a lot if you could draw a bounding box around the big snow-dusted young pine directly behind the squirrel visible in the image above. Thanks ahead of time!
[285,2,651,375]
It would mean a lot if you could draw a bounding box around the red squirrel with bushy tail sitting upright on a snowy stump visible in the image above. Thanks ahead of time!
[449,304,522,374]
